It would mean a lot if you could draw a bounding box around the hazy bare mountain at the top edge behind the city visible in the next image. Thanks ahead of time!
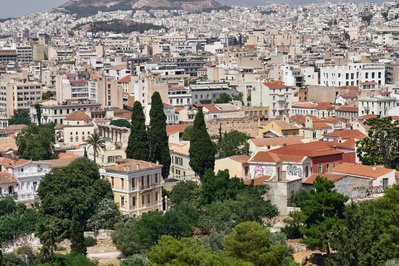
[56,0,224,17]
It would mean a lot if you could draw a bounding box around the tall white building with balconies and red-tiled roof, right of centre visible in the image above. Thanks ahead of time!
[250,81,298,118]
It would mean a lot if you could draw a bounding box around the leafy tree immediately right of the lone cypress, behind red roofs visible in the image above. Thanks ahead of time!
[217,130,250,158]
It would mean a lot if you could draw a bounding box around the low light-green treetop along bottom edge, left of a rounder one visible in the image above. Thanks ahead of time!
[148,236,251,266]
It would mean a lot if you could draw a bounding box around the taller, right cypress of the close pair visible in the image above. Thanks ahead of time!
[148,92,170,178]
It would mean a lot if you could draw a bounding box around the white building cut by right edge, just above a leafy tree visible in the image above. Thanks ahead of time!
[358,95,396,117]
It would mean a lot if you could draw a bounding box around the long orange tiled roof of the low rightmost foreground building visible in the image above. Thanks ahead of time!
[331,163,395,179]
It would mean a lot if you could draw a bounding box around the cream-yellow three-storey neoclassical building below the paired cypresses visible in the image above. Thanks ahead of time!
[100,159,162,217]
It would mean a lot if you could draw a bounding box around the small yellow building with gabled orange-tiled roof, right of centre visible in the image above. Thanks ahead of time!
[258,120,299,138]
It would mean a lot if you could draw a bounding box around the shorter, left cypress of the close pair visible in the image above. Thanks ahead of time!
[126,101,149,161]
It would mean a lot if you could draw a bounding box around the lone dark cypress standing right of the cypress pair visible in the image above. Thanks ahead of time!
[190,109,216,180]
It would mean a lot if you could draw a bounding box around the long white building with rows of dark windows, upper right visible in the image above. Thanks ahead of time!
[320,63,385,87]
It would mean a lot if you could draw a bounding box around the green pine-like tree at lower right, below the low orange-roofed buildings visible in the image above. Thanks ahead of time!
[300,176,348,254]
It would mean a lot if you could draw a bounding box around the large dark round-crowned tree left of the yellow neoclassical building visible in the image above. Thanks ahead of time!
[38,157,113,253]
